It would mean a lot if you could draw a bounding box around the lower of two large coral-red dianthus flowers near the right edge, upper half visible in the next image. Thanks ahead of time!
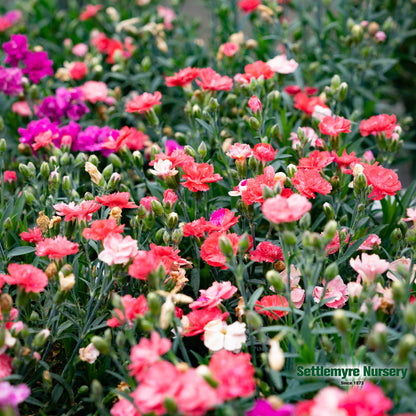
[363,163,402,201]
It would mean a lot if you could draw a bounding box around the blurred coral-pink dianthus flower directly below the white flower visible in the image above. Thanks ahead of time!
[209,350,256,401]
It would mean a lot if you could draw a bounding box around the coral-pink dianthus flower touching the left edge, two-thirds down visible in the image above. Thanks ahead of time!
[0,263,48,293]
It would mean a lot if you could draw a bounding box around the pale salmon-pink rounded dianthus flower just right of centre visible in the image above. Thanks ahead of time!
[262,194,312,224]
